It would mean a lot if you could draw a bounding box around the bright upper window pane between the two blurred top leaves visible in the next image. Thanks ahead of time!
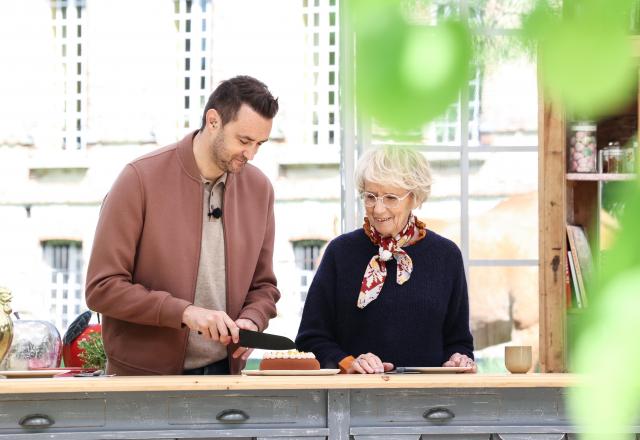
[469,37,538,146]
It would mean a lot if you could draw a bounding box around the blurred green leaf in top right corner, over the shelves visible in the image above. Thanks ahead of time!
[522,0,637,118]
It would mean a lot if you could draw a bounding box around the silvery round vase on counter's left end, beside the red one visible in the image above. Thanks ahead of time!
[0,319,62,371]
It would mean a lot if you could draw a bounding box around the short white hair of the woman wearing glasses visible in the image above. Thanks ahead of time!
[355,146,431,206]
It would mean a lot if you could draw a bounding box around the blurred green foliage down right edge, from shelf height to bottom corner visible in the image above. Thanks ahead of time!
[569,177,640,440]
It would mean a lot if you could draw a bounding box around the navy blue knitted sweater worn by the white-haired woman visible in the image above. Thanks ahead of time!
[296,229,473,368]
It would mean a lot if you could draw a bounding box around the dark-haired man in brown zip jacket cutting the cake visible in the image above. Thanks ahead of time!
[86,76,280,375]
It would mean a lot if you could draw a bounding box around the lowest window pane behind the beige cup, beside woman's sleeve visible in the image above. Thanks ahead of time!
[468,266,538,372]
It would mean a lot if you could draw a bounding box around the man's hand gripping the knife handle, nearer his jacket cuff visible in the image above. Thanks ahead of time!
[182,305,240,345]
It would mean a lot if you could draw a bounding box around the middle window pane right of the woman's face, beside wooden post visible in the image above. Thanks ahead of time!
[469,152,538,259]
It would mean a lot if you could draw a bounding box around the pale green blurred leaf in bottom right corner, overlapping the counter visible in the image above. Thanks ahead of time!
[569,268,640,440]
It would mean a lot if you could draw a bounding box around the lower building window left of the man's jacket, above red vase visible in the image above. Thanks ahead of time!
[41,240,86,334]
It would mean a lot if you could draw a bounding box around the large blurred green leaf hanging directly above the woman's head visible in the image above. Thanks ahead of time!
[350,1,471,130]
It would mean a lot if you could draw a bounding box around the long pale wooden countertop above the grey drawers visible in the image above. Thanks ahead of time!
[0,374,580,395]
